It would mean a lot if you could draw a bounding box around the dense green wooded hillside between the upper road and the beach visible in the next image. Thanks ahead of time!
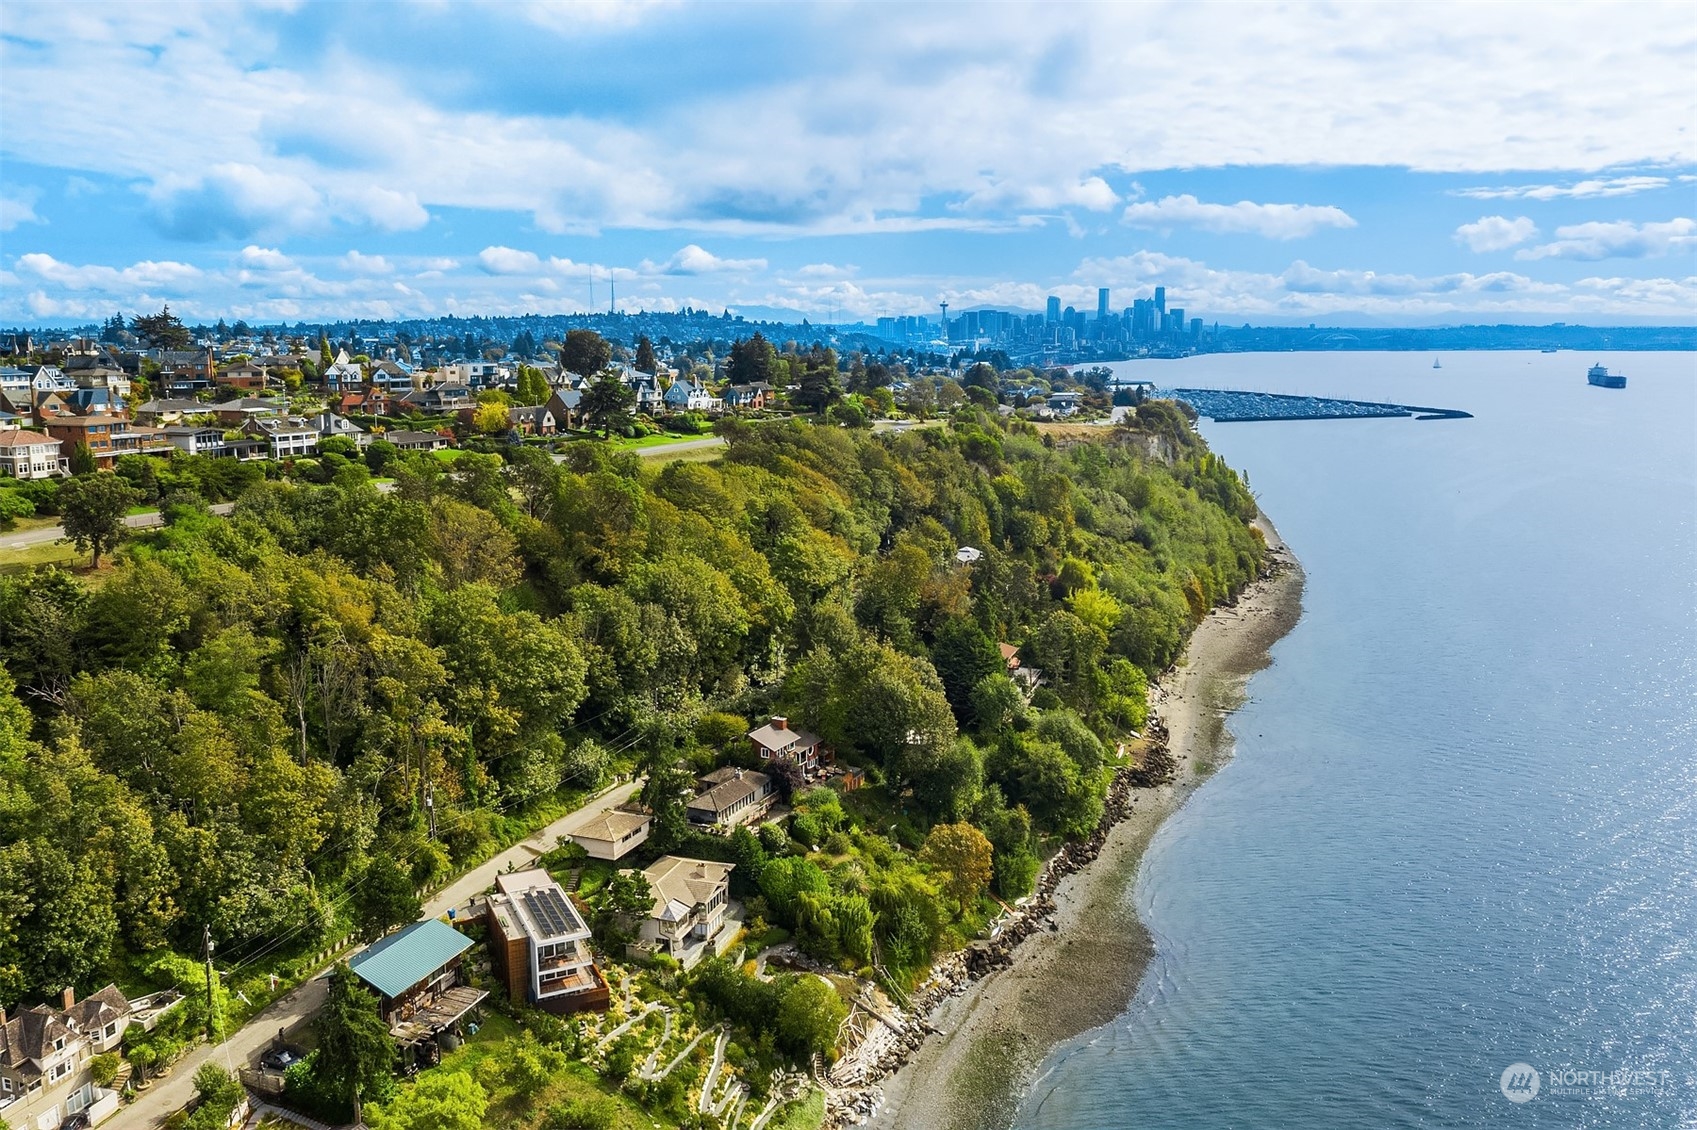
[0,402,1264,1011]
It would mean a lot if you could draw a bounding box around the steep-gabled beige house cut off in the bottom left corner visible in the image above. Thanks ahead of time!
[0,984,131,1130]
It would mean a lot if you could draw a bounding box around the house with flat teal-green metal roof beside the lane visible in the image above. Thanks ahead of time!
[348,918,489,1045]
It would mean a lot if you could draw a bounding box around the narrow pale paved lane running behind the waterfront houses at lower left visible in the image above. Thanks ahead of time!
[100,782,638,1130]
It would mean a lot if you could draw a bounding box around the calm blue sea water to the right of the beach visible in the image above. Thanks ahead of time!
[1017,351,1697,1130]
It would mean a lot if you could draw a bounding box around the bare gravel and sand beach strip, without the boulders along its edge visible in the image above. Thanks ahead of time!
[865,519,1303,1130]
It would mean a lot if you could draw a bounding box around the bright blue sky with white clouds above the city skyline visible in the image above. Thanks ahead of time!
[0,0,1697,324]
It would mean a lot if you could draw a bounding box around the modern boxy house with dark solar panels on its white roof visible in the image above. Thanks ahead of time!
[487,867,611,1015]
